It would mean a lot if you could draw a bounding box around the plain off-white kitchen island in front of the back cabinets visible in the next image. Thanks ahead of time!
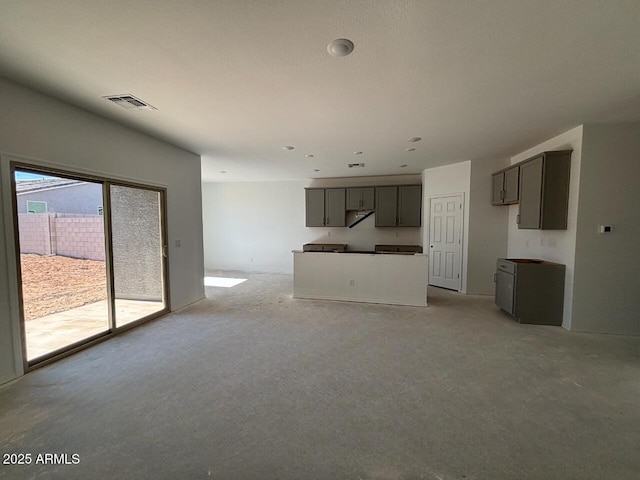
[293,250,429,307]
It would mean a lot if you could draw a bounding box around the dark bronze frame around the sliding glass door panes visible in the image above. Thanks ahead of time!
[2,155,171,375]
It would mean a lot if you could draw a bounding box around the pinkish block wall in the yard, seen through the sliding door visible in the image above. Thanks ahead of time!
[18,213,104,261]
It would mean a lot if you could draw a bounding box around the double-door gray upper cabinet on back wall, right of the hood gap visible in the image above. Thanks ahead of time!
[376,185,422,227]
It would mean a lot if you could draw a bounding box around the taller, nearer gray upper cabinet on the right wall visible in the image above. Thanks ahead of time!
[518,150,572,230]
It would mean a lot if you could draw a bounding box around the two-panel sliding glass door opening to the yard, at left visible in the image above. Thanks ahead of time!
[12,164,168,369]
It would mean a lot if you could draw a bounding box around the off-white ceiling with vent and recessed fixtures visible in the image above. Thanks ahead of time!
[0,0,640,181]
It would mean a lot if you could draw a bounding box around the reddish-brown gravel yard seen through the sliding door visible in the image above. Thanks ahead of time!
[20,254,107,320]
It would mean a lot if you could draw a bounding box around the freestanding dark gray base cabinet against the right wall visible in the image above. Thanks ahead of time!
[495,258,565,325]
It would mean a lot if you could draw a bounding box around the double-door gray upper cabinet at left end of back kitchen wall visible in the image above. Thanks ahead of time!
[305,188,347,227]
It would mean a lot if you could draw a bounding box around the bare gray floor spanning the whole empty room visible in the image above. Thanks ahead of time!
[0,272,640,480]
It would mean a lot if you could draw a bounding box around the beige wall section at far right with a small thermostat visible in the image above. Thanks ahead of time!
[572,122,640,335]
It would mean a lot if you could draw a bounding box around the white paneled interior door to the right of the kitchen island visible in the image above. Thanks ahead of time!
[429,195,463,291]
